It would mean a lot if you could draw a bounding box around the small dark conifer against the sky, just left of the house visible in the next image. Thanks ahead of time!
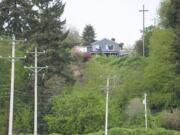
[82,25,95,46]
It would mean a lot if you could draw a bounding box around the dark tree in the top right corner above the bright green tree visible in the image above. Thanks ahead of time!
[159,0,180,74]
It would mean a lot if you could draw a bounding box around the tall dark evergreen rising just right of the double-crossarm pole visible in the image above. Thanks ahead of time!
[30,0,73,134]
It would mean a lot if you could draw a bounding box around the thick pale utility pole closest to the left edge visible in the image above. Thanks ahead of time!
[0,35,25,135]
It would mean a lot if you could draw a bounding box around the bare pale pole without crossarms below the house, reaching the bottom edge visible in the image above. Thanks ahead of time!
[105,77,110,135]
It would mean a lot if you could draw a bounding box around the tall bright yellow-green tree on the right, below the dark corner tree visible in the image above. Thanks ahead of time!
[145,29,175,109]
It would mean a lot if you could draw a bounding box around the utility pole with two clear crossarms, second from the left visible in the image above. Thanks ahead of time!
[24,47,48,135]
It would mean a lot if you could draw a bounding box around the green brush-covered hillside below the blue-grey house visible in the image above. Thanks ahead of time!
[45,56,178,135]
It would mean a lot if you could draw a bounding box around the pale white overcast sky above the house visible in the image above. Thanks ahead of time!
[64,0,161,46]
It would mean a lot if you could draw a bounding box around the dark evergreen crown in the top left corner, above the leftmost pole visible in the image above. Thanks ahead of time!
[0,0,36,38]
